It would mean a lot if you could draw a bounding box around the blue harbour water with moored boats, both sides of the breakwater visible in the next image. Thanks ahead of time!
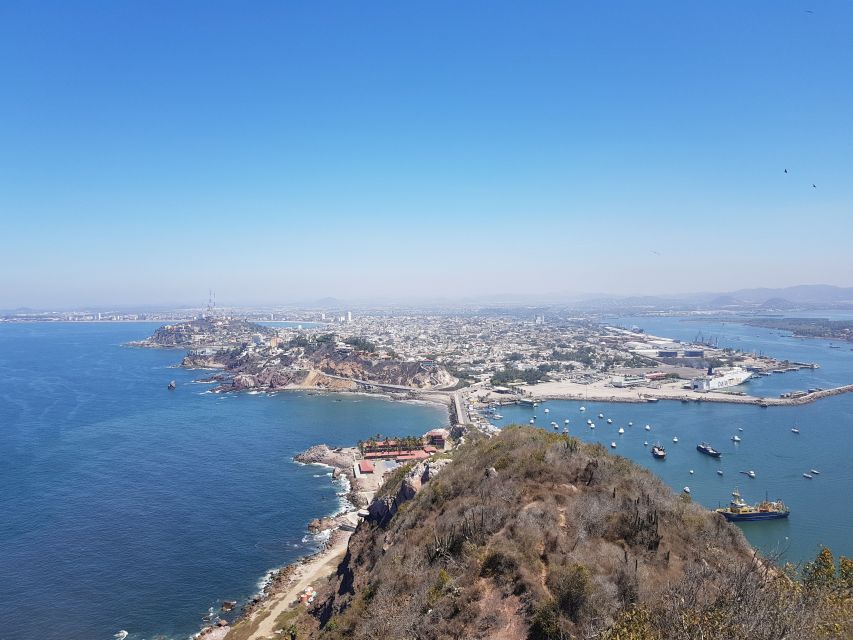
[498,314,853,562]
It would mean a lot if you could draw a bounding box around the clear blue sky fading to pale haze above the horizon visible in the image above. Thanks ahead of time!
[0,0,853,308]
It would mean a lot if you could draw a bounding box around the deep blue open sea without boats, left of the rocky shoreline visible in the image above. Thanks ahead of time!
[0,323,447,640]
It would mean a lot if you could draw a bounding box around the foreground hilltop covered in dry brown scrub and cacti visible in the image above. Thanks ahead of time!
[299,427,853,640]
